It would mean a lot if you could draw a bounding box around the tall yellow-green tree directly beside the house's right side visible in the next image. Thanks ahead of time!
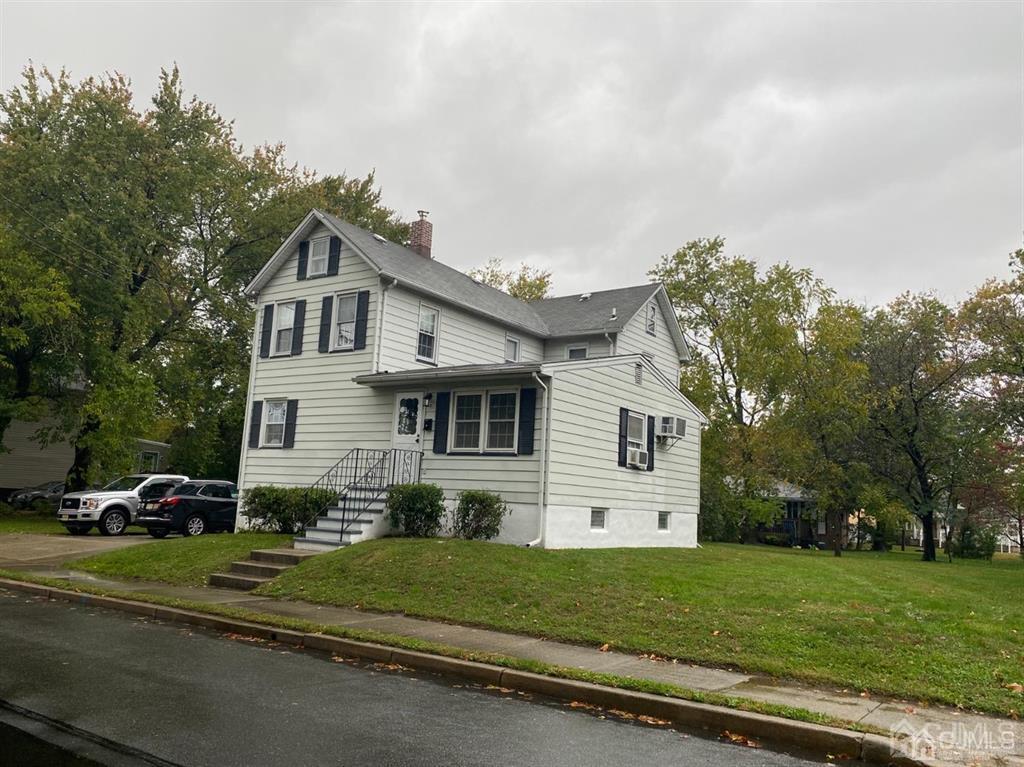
[650,238,825,538]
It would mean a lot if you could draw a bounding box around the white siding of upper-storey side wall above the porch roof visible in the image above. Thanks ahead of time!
[380,286,544,372]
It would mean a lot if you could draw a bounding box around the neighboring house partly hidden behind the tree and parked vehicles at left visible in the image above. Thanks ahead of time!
[0,421,171,498]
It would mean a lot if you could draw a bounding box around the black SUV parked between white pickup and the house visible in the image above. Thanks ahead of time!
[138,479,239,538]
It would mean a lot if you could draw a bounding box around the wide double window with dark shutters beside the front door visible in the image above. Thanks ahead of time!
[452,391,519,453]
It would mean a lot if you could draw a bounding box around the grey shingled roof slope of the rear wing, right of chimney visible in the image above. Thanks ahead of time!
[528,283,662,336]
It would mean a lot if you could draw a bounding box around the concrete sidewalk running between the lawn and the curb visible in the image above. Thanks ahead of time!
[16,568,1024,765]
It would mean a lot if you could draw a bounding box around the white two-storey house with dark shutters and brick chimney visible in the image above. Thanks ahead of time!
[239,210,707,548]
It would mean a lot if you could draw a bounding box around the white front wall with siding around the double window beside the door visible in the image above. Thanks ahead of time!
[413,377,545,544]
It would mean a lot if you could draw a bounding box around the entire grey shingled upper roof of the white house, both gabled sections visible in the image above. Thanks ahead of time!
[245,208,689,359]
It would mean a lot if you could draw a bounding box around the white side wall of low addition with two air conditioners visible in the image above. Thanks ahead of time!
[544,360,700,548]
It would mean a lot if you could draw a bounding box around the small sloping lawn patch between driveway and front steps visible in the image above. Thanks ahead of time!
[67,532,293,586]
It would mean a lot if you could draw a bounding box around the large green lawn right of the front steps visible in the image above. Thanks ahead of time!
[256,539,1024,715]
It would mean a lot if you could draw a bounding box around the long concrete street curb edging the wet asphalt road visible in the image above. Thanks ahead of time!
[0,578,937,767]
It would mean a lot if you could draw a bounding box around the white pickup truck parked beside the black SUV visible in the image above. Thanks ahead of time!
[57,474,188,536]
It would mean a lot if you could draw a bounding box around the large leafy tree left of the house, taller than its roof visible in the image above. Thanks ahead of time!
[0,67,408,487]
